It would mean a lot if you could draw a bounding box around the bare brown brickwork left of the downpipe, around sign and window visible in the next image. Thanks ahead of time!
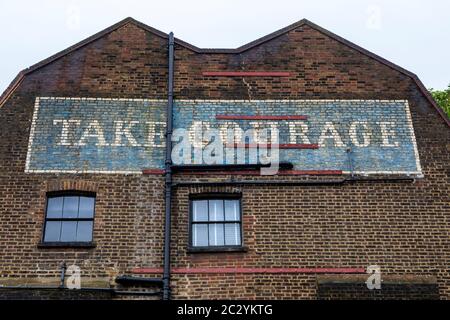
[0,24,167,288]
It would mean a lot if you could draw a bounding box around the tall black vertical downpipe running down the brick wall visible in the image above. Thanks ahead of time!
[163,32,174,300]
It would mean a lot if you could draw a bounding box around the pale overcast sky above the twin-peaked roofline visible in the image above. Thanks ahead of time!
[0,0,450,91]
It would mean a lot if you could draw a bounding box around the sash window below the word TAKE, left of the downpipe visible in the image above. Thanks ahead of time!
[43,193,95,243]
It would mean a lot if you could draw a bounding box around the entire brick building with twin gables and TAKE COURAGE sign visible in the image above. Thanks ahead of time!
[0,18,450,299]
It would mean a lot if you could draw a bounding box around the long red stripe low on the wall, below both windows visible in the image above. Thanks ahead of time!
[131,267,366,274]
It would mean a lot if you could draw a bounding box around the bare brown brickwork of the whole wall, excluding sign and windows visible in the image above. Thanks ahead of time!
[0,23,450,299]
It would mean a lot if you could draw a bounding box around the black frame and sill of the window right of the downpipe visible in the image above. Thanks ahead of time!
[188,193,247,253]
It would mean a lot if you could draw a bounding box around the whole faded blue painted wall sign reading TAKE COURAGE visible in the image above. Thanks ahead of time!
[26,98,421,175]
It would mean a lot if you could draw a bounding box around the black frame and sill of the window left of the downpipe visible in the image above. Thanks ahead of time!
[38,190,97,248]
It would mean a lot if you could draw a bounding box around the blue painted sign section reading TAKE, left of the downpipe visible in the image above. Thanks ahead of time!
[26,98,166,173]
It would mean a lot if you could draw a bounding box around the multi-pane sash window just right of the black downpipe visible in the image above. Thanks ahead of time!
[190,196,242,248]
